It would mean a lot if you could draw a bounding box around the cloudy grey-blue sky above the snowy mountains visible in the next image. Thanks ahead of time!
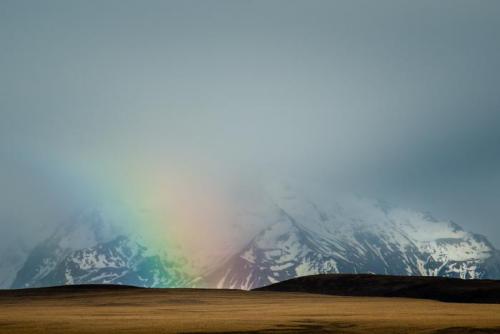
[0,0,500,247]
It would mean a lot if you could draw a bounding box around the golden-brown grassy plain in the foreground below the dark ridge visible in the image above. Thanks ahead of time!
[0,289,500,334]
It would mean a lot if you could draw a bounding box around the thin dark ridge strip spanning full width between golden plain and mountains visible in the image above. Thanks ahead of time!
[0,274,500,304]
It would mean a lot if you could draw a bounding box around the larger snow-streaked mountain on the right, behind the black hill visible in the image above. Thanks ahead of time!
[206,191,500,289]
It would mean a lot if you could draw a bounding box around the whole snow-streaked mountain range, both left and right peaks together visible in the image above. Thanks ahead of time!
[4,187,500,289]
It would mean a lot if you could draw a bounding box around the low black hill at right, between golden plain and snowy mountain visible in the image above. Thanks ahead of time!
[254,274,500,304]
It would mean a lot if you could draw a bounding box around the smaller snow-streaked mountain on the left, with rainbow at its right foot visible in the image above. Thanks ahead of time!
[11,209,193,288]
